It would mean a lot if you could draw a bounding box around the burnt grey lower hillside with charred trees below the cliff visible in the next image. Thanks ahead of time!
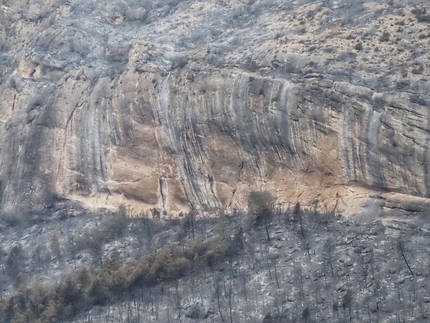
[0,207,430,323]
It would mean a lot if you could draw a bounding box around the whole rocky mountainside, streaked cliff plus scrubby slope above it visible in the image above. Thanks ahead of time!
[0,0,430,218]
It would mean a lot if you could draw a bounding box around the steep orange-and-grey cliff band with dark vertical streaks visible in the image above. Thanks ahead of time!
[0,69,429,212]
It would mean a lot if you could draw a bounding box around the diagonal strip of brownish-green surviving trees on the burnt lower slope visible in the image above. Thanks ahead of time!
[0,214,240,322]
